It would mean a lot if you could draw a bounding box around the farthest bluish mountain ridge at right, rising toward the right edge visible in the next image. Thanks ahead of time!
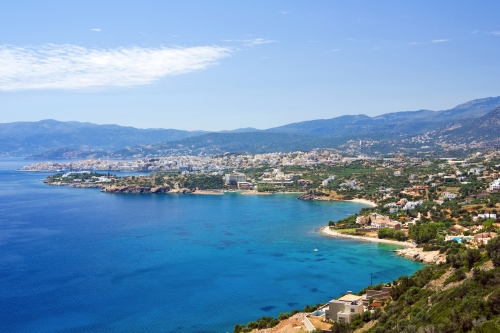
[267,96,500,137]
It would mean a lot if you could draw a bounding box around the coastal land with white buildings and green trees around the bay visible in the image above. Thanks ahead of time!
[21,150,500,333]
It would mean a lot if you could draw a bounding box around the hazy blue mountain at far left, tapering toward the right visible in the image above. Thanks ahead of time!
[0,120,207,155]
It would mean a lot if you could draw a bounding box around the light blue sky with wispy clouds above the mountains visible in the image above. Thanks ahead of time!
[0,0,500,131]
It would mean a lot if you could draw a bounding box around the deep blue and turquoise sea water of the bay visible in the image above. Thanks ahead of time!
[0,159,422,332]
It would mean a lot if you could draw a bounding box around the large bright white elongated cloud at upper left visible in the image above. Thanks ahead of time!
[0,44,232,91]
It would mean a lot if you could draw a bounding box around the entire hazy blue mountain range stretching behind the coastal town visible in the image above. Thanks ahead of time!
[0,96,500,158]
